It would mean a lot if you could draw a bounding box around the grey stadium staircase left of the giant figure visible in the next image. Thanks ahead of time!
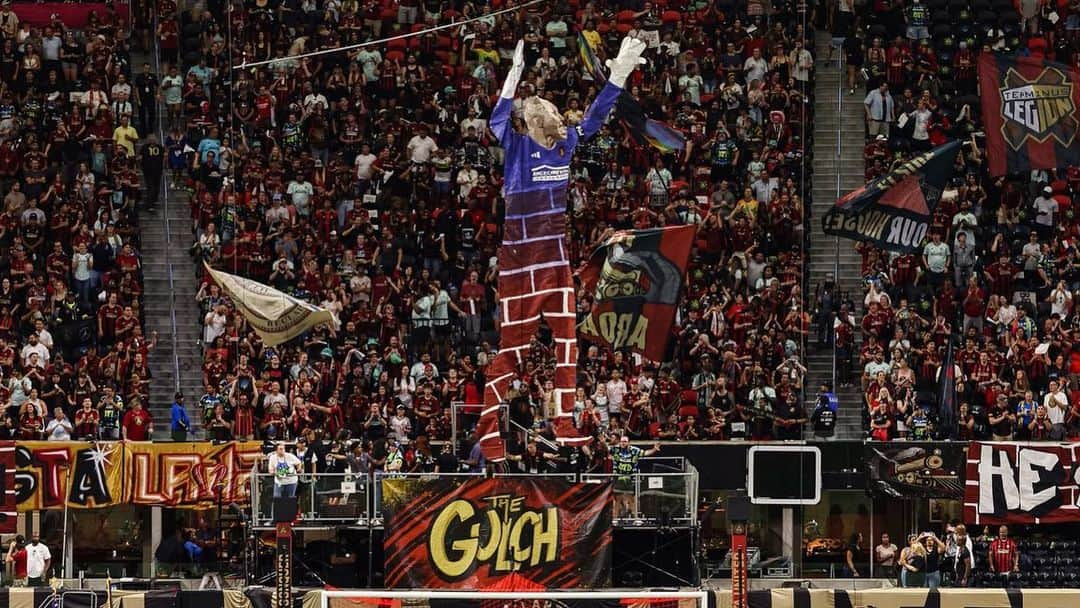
[133,49,203,441]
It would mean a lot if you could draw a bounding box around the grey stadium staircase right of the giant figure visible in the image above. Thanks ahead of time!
[805,31,866,440]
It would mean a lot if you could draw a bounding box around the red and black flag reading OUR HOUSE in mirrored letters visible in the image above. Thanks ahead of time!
[822,141,960,253]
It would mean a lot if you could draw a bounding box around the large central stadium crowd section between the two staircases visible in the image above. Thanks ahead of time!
[159,1,813,468]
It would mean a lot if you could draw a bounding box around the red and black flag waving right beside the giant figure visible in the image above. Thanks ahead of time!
[578,226,697,361]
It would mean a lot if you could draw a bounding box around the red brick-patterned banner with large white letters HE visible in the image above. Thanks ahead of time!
[963,442,1080,525]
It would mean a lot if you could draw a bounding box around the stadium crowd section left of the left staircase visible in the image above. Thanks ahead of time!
[0,1,158,440]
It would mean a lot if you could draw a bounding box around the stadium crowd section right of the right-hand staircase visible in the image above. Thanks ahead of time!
[819,0,1080,441]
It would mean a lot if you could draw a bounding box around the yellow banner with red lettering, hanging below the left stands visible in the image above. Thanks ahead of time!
[14,442,261,511]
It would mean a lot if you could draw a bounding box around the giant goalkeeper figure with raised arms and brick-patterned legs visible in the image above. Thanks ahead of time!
[477,38,646,462]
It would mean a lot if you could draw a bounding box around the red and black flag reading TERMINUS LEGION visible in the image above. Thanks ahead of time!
[978,53,1080,175]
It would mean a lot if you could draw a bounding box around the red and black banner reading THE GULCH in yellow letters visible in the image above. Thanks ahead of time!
[382,477,611,590]
